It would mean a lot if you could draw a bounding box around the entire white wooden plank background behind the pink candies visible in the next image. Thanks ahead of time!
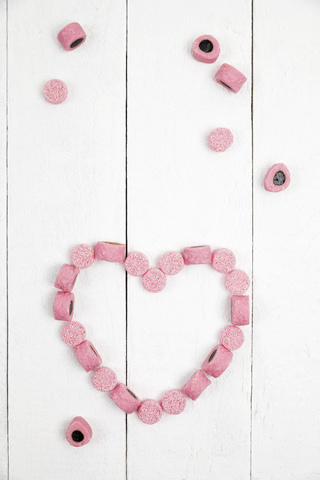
[0,0,320,480]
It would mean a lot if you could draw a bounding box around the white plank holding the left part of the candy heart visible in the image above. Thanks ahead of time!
[7,0,126,480]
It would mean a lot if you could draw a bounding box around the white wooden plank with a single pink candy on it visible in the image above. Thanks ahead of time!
[252,0,320,480]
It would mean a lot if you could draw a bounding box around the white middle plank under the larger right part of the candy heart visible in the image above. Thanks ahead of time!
[128,0,252,480]
